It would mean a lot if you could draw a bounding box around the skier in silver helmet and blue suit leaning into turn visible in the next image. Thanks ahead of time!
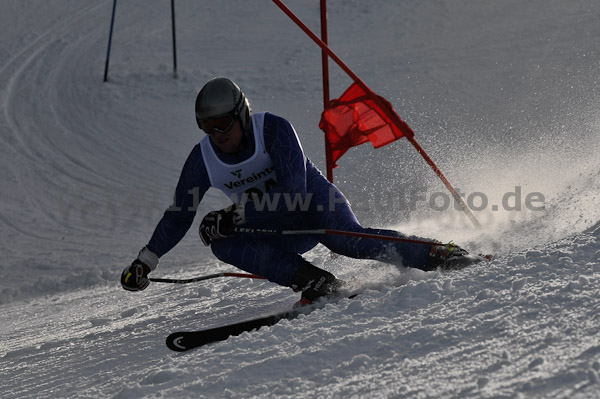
[121,77,476,303]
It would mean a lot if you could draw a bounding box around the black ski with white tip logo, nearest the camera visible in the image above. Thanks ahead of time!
[167,294,358,352]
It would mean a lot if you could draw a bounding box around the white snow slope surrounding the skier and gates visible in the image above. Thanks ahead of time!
[0,0,600,398]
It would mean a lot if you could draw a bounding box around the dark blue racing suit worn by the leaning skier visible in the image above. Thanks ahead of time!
[147,113,431,286]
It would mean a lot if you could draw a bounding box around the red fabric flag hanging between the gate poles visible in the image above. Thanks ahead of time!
[319,82,414,167]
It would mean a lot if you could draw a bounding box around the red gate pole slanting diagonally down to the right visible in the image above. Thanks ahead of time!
[273,0,481,228]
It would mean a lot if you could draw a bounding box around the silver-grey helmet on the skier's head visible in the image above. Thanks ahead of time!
[196,78,250,131]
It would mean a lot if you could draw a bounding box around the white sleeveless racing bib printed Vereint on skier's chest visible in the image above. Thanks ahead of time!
[200,113,277,202]
